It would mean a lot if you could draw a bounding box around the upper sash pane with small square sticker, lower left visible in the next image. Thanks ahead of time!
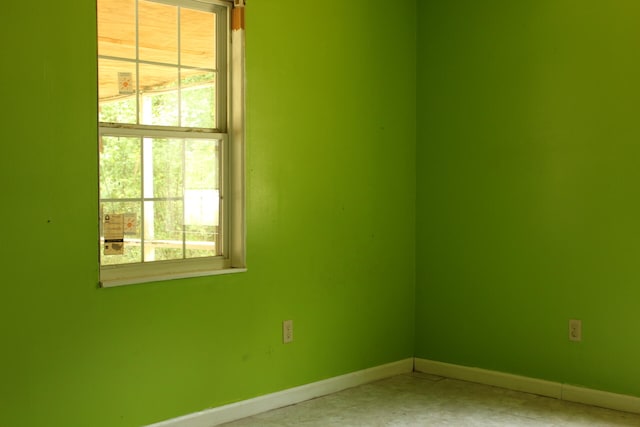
[98,59,136,123]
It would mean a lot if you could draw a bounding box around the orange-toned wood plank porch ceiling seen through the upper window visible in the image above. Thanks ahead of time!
[98,0,216,100]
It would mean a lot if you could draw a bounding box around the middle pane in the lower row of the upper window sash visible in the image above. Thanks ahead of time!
[140,64,179,126]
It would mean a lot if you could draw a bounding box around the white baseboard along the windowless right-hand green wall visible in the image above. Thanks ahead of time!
[414,358,640,414]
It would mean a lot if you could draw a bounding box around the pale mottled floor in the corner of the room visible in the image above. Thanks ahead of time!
[224,373,640,427]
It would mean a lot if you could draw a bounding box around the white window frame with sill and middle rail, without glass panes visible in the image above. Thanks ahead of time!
[98,0,246,288]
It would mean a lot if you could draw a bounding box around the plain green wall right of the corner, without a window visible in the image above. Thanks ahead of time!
[416,0,640,395]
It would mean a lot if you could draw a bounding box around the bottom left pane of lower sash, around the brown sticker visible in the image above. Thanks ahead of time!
[100,202,142,265]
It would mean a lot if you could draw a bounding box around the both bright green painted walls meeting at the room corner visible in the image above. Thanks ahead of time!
[6,0,640,427]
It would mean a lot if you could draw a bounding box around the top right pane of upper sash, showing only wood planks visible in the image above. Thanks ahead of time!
[180,8,216,69]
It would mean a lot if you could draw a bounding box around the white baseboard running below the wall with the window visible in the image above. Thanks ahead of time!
[147,358,414,427]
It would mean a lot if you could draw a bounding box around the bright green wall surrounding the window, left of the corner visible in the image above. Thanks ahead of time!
[0,0,415,427]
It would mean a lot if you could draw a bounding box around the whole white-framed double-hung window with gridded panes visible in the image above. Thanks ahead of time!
[98,0,244,286]
